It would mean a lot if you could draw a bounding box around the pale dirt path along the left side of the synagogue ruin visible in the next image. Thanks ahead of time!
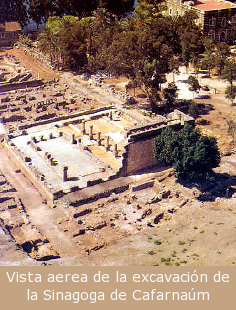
[0,145,81,257]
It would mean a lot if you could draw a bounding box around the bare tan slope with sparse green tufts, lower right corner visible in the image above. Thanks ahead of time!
[50,167,236,266]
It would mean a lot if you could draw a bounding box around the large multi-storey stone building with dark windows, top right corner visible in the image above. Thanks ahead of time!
[166,0,236,42]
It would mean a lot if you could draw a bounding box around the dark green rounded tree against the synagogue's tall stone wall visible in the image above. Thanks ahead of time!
[154,124,220,179]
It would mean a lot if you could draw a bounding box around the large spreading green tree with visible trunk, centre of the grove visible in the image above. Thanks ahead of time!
[89,17,172,111]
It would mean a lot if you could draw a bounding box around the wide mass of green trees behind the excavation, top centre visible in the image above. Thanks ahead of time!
[34,0,206,112]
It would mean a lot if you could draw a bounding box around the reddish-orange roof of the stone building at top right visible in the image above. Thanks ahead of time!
[192,0,236,11]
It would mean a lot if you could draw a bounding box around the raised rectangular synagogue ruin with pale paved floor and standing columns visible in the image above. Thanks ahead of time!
[1,105,194,206]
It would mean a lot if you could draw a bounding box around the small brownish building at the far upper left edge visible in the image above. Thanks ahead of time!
[0,22,22,46]
